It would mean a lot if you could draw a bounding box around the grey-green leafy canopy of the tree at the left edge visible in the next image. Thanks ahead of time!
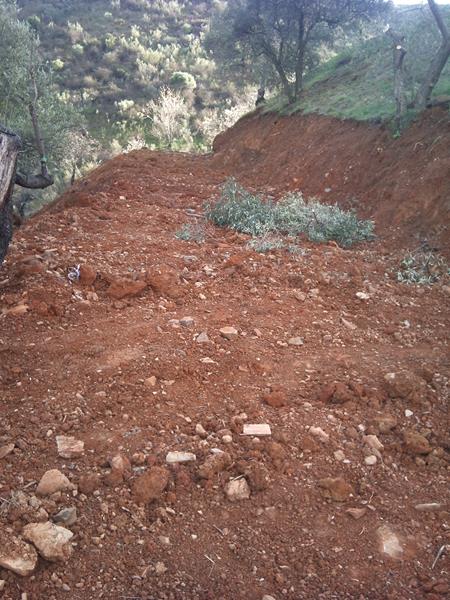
[0,0,83,182]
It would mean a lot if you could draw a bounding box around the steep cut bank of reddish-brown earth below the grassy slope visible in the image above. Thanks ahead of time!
[213,110,450,249]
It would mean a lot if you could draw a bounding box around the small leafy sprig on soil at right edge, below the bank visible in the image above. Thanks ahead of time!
[397,249,450,285]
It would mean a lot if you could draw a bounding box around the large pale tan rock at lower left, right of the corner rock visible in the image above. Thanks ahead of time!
[23,521,73,562]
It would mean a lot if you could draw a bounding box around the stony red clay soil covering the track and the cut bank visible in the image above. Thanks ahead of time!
[0,110,450,600]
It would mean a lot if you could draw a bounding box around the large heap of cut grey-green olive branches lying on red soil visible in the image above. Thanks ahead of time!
[206,179,374,248]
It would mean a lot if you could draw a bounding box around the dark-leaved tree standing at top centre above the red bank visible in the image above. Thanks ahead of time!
[208,0,390,103]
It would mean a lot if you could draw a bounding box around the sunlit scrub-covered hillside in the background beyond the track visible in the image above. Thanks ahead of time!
[19,0,254,147]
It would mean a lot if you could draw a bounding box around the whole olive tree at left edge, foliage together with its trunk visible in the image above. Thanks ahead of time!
[0,0,81,264]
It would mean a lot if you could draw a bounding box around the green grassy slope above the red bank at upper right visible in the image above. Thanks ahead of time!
[266,7,450,121]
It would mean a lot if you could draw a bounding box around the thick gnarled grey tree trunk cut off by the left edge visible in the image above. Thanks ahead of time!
[0,127,21,265]
